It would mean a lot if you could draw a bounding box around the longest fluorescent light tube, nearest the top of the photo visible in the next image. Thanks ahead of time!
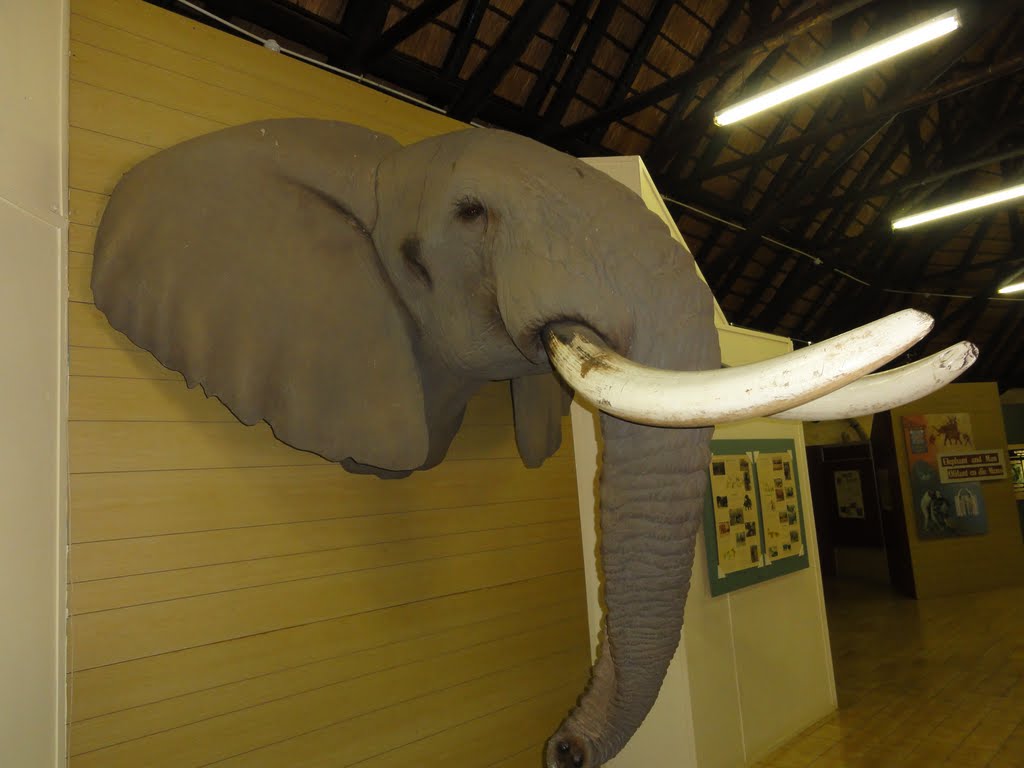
[715,9,961,125]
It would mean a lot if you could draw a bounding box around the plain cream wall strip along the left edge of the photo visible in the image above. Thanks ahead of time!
[0,0,68,768]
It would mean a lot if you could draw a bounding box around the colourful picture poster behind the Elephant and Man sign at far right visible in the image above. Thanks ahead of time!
[903,414,988,539]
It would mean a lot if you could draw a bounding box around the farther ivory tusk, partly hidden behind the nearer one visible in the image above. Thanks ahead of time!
[771,341,978,421]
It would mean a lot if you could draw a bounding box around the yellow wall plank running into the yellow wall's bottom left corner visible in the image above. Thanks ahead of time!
[71,651,579,768]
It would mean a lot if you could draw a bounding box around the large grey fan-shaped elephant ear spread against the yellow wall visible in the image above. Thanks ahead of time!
[92,120,430,474]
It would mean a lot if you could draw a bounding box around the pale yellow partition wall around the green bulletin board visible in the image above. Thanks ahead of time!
[684,328,837,768]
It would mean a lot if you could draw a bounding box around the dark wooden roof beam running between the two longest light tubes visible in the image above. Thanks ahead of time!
[705,54,1024,179]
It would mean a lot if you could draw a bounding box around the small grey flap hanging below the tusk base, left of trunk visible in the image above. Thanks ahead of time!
[512,374,572,468]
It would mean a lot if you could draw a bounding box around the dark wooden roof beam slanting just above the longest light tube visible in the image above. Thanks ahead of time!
[553,0,877,138]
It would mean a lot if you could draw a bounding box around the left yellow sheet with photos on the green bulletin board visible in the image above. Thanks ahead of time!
[711,454,761,573]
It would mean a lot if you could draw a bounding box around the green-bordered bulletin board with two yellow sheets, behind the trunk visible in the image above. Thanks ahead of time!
[705,439,808,597]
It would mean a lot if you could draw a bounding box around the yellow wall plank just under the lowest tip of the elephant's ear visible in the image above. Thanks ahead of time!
[70,460,575,544]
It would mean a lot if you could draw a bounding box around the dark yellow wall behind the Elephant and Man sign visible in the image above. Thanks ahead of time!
[892,382,1024,598]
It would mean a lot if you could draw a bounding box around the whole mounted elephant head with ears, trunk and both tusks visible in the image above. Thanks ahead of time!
[92,119,976,768]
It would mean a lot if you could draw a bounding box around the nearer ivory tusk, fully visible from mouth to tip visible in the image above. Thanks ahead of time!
[544,309,932,427]
